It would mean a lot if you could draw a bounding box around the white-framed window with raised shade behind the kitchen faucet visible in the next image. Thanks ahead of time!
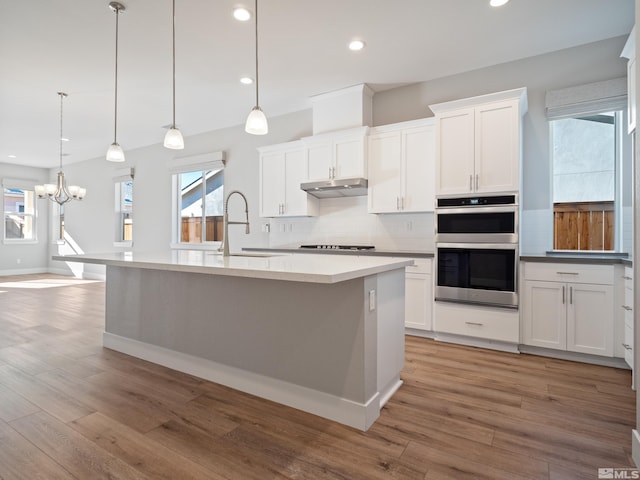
[169,152,224,245]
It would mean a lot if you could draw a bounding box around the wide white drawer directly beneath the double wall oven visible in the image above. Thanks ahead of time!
[434,302,520,343]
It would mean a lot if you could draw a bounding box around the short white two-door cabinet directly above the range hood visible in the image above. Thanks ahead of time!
[302,127,369,181]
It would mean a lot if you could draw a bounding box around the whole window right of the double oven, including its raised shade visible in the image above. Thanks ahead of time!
[545,78,632,251]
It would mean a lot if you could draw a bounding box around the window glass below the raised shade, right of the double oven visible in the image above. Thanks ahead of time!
[551,111,622,250]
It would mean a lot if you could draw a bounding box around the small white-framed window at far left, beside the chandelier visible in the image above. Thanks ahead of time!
[2,179,37,243]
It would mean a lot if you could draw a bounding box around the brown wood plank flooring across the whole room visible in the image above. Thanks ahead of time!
[0,275,635,480]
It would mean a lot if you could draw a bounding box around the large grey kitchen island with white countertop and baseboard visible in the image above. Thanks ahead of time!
[53,250,412,430]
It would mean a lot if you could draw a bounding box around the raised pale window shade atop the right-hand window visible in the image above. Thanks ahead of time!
[545,77,627,120]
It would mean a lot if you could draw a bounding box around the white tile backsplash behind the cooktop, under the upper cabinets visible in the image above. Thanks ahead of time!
[262,196,434,252]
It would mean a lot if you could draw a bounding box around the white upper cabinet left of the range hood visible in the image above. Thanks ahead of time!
[259,141,318,217]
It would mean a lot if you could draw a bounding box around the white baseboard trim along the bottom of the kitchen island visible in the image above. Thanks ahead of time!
[102,332,382,431]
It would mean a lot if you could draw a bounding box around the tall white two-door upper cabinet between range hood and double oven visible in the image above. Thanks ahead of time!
[368,118,435,213]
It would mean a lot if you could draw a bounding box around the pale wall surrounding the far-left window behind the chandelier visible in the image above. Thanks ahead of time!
[0,163,51,275]
